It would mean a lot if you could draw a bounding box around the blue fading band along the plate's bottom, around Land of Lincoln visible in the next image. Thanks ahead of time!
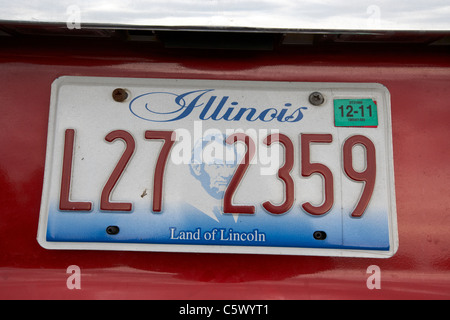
[47,200,389,250]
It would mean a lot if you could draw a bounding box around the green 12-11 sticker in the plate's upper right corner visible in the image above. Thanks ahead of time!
[334,99,378,127]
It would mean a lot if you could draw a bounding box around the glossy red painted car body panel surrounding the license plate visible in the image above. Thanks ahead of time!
[0,38,450,299]
